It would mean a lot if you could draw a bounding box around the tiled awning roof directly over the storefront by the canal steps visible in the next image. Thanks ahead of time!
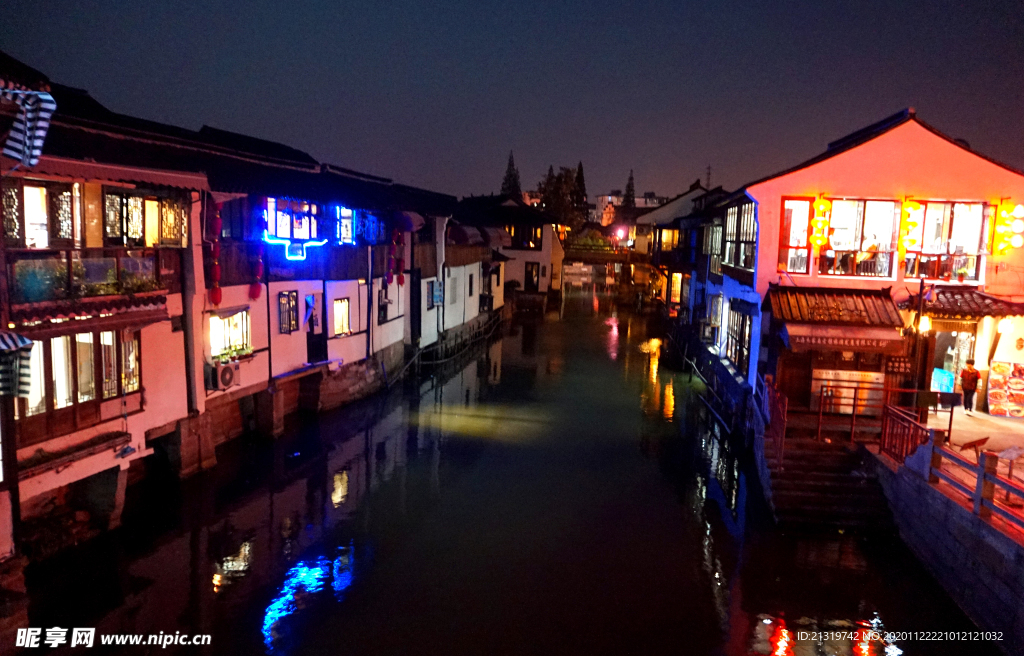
[767,285,903,327]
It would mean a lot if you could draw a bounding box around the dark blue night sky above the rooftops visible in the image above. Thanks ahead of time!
[0,0,1024,195]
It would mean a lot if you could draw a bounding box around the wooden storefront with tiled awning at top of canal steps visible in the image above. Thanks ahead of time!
[764,286,910,414]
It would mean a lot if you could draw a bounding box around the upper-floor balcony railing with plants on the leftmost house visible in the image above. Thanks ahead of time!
[6,249,181,304]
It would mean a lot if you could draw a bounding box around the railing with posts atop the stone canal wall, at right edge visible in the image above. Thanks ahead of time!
[928,431,1024,530]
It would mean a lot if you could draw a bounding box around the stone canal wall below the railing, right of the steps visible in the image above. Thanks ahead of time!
[872,448,1024,654]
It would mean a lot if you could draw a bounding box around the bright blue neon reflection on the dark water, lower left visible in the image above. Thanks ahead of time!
[263,544,354,654]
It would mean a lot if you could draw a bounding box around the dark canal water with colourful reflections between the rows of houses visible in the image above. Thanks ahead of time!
[27,298,998,656]
